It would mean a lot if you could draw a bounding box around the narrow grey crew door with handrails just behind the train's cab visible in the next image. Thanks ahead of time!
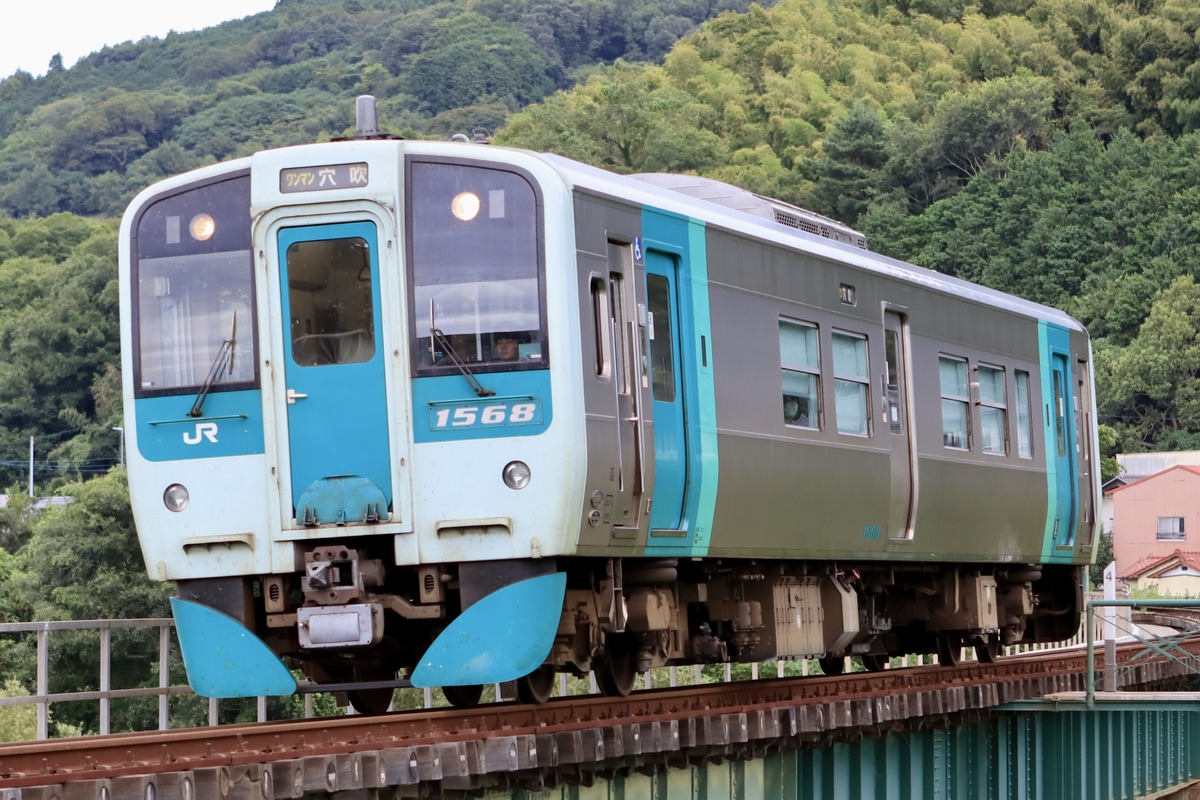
[607,241,646,539]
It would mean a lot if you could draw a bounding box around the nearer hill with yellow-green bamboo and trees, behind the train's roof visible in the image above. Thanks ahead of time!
[498,0,1200,451]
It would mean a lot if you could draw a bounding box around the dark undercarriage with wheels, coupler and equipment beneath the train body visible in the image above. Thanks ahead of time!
[179,551,1081,712]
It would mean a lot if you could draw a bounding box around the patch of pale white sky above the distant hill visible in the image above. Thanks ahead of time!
[0,0,275,80]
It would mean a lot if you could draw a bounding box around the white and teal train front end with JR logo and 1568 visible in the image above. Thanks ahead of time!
[121,139,584,710]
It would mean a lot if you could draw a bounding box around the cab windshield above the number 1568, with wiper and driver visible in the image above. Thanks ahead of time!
[406,160,547,374]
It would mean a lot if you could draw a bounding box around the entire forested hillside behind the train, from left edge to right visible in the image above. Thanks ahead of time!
[0,0,1200,489]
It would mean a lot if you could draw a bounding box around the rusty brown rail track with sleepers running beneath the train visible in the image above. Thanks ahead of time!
[0,637,1200,800]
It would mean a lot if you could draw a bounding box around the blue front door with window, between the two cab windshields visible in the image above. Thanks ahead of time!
[278,222,392,527]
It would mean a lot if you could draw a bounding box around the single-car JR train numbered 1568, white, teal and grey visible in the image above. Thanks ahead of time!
[120,96,1099,712]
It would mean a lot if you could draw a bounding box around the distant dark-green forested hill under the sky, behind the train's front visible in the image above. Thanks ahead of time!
[0,0,768,216]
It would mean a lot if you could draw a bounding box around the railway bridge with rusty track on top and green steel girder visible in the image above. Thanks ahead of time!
[0,609,1200,800]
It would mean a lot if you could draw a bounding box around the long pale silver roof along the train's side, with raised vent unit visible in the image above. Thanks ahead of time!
[542,154,1085,332]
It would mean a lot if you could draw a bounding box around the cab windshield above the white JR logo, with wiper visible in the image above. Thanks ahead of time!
[133,176,257,397]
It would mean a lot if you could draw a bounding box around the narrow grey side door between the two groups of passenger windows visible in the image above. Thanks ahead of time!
[883,311,917,540]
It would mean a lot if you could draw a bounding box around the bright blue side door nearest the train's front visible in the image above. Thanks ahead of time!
[646,251,688,540]
